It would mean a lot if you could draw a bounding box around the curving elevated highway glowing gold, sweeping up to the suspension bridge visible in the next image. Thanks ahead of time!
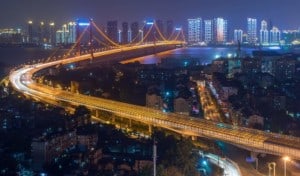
[9,42,300,160]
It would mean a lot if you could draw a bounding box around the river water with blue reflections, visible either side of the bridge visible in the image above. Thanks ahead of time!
[0,47,292,66]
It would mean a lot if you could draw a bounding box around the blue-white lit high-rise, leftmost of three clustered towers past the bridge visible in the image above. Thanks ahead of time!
[188,18,202,44]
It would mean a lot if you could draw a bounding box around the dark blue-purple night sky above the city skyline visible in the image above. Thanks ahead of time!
[0,0,300,29]
